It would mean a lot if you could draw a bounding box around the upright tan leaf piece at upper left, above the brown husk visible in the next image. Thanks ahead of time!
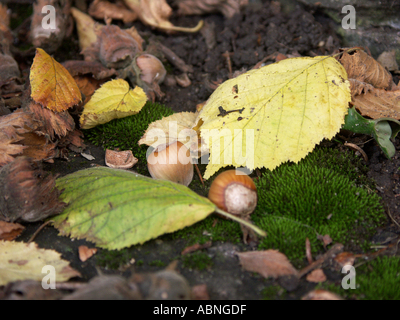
[71,8,100,50]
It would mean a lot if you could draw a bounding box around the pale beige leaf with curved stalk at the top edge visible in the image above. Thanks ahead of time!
[124,0,203,32]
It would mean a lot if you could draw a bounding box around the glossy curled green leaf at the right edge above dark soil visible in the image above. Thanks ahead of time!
[343,107,400,159]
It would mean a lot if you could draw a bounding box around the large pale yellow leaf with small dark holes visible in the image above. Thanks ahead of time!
[195,56,351,179]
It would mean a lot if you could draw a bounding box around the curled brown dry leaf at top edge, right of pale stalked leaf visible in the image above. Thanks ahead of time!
[175,0,249,18]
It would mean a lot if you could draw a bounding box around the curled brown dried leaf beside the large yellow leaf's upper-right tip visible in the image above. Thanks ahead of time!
[339,50,393,89]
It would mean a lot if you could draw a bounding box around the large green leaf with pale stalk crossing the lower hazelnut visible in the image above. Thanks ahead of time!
[52,167,265,250]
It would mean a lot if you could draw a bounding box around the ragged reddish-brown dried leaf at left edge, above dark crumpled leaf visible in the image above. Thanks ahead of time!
[0,110,39,167]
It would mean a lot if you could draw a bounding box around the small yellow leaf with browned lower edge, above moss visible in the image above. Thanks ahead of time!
[79,79,147,129]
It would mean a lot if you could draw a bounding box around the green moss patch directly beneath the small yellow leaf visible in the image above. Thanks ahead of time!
[84,102,173,174]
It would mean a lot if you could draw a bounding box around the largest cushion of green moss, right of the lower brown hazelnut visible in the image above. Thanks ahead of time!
[252,148,386,261]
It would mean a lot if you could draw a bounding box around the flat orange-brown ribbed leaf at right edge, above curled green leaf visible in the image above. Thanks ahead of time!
[352,89,400,120]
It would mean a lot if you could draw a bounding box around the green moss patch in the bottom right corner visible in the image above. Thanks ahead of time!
[322,256,400,300]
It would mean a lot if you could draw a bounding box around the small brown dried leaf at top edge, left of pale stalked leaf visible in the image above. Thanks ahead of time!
[88,0,137,23]
